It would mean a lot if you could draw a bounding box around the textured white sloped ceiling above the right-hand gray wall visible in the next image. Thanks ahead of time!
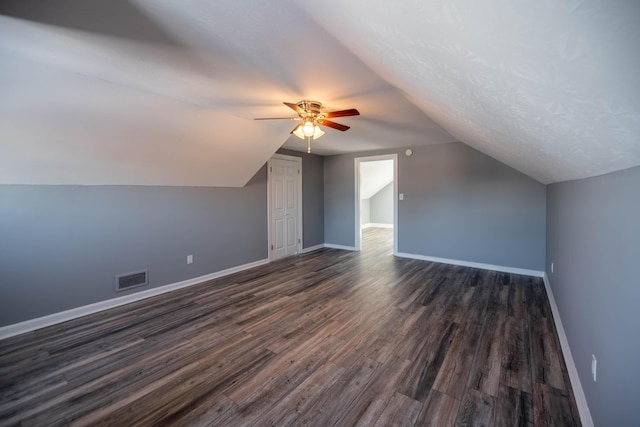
[304,0,640,183]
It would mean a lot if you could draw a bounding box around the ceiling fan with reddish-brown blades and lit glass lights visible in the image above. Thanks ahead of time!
[254,100,360,153]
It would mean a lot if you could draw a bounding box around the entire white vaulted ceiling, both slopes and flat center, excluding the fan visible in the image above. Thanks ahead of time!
[0,0,640,186]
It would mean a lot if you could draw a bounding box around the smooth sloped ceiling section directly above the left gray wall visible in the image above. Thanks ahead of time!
[0,52,288,186]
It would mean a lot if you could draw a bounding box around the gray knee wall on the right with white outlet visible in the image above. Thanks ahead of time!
[546,167,640,426]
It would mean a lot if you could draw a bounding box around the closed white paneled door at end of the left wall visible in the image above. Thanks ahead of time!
[267,154,302,261]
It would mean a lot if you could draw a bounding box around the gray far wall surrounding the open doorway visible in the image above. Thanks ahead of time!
[324,143,546,271]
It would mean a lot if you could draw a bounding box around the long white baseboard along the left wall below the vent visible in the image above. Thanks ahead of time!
[0,259,269,339]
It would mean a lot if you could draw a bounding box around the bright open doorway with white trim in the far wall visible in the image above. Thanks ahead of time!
[355,154,398,255]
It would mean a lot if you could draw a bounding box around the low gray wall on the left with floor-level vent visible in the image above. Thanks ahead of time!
[0,167,268,326]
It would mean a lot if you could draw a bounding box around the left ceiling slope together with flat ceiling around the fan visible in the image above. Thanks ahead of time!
[0,0,455,186]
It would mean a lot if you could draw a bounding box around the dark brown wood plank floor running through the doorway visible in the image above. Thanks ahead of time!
[0,229,580,427]
